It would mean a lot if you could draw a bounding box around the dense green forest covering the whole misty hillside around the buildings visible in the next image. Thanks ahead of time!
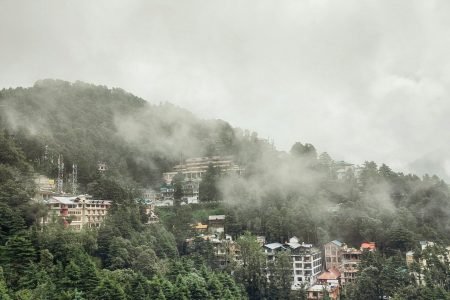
[0,80,450,299]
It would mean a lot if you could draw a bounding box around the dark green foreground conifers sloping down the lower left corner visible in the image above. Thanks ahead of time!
[0,133,246,300]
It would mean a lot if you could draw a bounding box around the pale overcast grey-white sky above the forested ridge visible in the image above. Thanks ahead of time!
[0,0,450,181]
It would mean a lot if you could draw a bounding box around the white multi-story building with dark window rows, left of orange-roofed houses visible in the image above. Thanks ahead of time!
[263,237,322,290]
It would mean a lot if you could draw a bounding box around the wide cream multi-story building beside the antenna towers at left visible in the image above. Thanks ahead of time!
[42,195,111,230]
